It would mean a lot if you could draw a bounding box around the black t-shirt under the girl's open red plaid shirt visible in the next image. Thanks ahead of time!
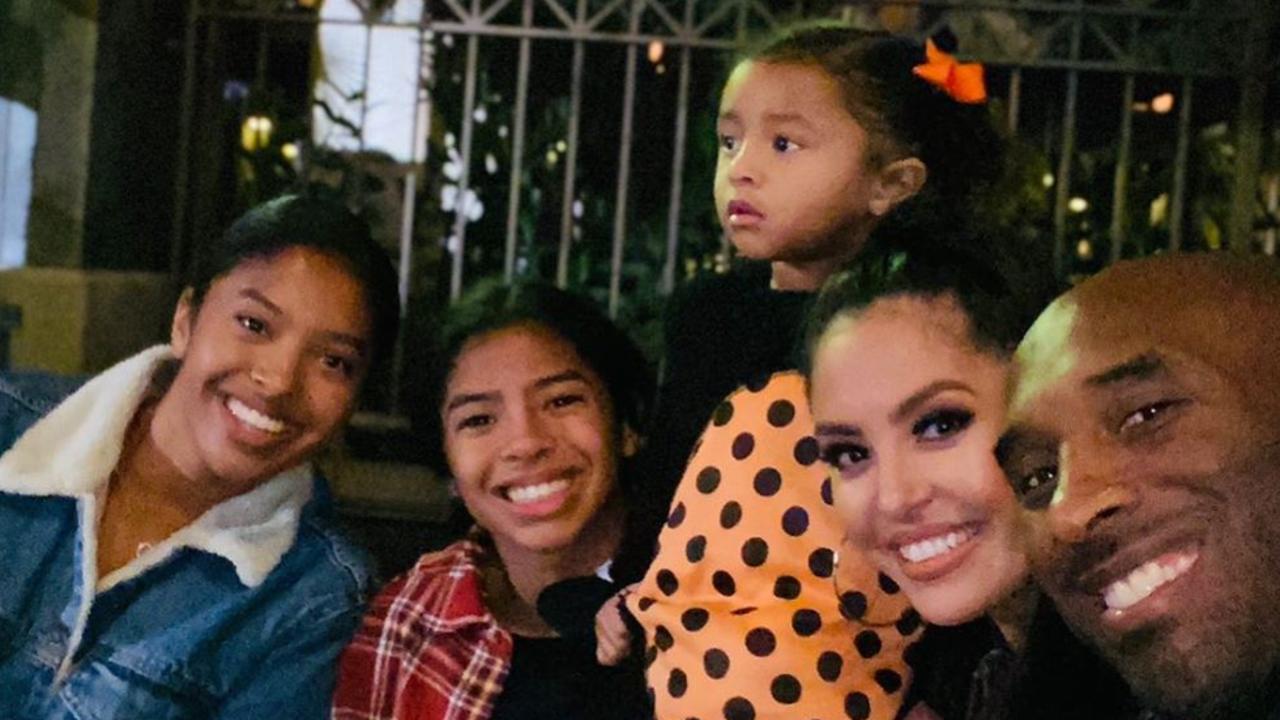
[490,635,653,720]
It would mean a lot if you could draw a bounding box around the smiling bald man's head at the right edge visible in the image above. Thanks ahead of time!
[997,255,1280,719]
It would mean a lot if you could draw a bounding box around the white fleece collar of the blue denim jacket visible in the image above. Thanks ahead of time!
[0,346,312,587]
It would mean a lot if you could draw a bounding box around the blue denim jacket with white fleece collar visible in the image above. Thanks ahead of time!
[0,348,369,720]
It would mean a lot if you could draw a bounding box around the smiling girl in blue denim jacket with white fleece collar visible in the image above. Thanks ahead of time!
[0,197,399,720]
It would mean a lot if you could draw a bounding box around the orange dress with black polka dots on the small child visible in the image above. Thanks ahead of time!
[627,372,920,720]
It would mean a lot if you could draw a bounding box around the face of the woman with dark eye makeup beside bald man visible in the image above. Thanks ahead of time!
[810,296,1027,625]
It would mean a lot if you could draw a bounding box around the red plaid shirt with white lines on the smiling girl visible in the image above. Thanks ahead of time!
[333,539,513,720]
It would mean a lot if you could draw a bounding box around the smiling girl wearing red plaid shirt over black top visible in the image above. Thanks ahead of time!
[334,284,653,720]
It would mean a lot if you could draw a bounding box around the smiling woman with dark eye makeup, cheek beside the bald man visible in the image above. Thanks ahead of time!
[806,227,1125,720]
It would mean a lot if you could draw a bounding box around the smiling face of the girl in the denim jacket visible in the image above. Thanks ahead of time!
[151,247,371,495]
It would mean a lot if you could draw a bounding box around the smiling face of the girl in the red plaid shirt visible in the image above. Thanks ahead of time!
[440,324,630,561]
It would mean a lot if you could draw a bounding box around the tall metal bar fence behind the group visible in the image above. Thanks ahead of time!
[173,0,1280,409]
